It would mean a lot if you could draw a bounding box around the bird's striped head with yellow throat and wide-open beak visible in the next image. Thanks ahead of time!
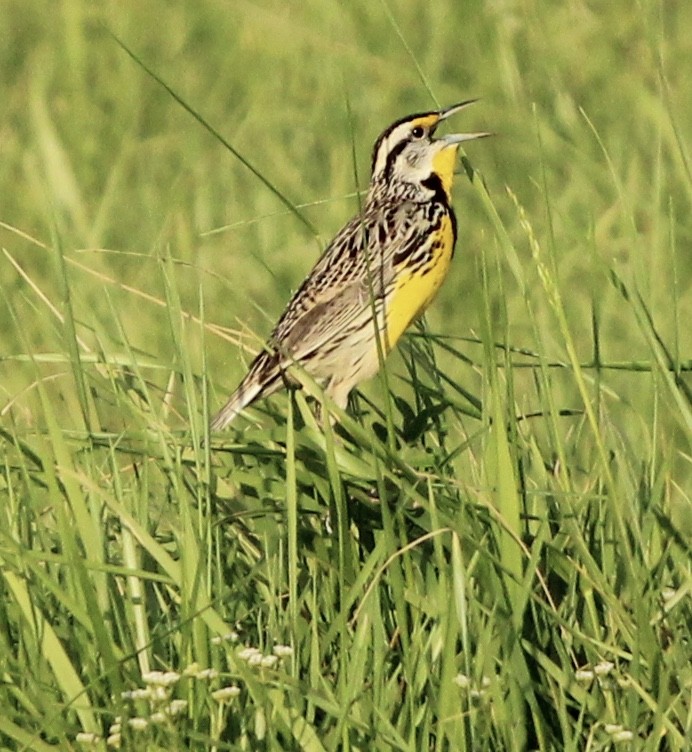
[372,99,490,200]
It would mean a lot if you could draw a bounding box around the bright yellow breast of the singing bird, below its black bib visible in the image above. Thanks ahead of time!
[387,216,454,349]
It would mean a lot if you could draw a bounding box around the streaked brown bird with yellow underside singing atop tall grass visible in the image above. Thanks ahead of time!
[209,99,491,431]
